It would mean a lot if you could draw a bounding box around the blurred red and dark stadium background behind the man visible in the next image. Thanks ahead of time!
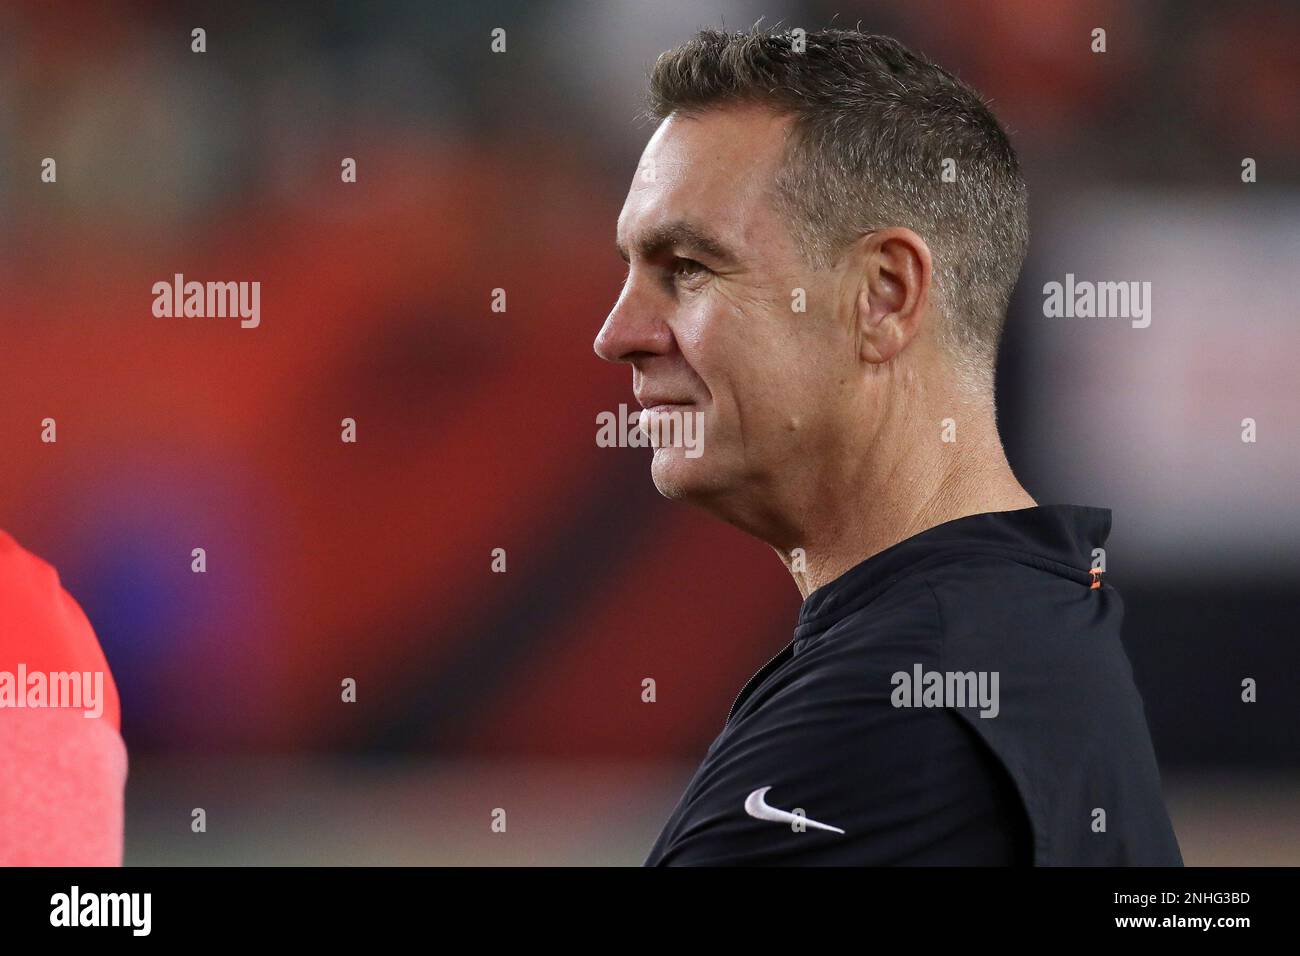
[0,0,1300,864]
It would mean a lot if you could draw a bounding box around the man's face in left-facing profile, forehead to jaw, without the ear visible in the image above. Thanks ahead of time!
[595,107,858,524]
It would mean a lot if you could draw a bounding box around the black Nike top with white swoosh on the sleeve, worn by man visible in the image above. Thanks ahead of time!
[646,505,1182,866]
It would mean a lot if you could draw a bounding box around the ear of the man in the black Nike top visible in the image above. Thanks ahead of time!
[855,226,931,364]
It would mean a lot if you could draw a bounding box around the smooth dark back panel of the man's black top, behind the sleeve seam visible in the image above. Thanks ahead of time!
[926,555,1182,866]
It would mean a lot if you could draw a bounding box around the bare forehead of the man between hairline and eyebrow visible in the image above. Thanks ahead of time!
[618,105,789,255]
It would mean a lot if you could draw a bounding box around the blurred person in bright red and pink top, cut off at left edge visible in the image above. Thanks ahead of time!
[0,531,126,866]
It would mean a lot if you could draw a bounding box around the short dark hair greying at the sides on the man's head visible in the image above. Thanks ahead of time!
[649,26,1030,389]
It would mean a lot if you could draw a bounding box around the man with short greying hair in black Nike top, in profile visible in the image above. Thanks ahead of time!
[595,29,1182,865]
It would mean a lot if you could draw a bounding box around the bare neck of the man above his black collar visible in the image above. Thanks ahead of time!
[774,390,1036,598]
